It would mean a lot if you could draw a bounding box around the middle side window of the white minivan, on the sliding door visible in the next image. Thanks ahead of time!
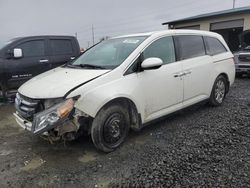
[175,35,206,60]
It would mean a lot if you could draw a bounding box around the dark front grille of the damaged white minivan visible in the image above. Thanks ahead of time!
[15,93,44,121]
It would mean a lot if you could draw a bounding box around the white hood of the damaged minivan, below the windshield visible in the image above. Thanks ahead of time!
[18,67,109,99]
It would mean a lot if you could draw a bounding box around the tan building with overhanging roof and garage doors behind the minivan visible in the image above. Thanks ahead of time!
[163,7,250,51]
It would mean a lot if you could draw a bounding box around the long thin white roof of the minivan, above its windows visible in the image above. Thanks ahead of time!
[114,29,220,38]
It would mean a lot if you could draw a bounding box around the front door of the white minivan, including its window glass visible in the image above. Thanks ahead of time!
[138,36,183,122]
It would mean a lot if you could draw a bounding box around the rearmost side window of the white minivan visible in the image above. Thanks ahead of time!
[204,37,227,55]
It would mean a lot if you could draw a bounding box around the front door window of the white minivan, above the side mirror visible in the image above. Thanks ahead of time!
[143,37,175,64]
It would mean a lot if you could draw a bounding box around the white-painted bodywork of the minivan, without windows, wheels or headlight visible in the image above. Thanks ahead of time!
[19,30,235,123]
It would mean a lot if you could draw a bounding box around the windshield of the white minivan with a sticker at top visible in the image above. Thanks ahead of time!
[69,36,146,69]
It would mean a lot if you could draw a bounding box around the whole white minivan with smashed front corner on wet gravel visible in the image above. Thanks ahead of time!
[14,30,235,152]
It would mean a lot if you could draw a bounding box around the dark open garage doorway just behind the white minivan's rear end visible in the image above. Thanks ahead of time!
[213,27,243,52]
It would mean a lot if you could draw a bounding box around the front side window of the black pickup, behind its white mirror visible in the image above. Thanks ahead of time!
[16,40,45,57]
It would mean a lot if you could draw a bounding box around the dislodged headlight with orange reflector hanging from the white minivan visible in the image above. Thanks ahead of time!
[31,98,75,134]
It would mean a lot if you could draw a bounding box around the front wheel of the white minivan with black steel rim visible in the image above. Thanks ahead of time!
[91,104,130,152]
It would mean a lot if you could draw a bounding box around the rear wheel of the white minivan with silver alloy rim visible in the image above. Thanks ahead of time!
[209,75,228,106]
